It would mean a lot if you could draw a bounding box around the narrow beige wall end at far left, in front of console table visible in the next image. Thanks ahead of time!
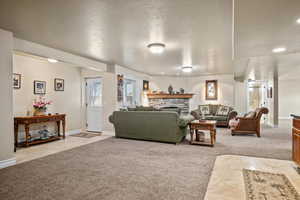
[0,29,14,162]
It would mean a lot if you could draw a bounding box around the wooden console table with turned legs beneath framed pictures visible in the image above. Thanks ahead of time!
[14,114,66,152]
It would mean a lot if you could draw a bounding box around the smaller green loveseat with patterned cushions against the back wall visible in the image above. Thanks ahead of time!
[191,104,238,127]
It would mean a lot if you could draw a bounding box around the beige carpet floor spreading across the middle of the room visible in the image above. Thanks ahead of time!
[0,124,291,200]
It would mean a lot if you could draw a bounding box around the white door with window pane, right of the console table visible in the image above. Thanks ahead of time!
[86,78,103,132]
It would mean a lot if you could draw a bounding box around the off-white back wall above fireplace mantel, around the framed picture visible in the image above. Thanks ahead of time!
[150,75,235,109]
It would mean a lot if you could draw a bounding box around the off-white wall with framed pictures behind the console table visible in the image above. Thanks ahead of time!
[13,54,81,131]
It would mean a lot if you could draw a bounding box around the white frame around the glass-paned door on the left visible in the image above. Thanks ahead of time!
[82,76,104,133]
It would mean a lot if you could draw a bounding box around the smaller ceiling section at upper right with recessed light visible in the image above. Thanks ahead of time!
[235,0,300,78]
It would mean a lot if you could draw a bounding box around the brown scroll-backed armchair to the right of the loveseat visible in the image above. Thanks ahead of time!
[231,107,269,137]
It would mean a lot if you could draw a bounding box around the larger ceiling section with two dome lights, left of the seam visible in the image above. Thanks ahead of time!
[0,0,233,75]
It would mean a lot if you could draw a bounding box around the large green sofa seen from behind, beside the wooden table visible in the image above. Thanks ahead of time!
[109,111,194,144]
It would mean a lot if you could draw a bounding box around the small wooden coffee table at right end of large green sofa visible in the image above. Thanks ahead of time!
[189,120,217,147]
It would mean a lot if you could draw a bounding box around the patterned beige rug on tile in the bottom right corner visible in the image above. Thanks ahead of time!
[243,169,300,200]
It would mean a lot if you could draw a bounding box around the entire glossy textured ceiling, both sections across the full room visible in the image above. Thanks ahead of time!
[0,0,300,76]
